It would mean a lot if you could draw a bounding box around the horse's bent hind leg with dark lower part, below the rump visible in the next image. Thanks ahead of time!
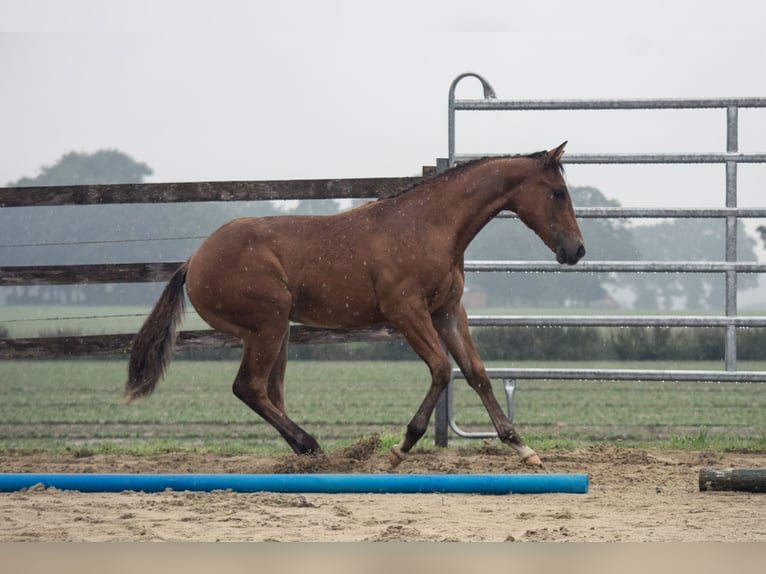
[234,336,322,454]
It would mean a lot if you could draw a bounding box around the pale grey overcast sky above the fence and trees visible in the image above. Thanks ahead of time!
[0,0,766,213]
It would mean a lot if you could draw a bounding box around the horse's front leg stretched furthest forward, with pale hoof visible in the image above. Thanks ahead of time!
[433,304,542,466]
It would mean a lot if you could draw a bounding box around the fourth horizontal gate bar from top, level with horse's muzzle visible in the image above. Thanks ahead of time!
[465,260,766,273]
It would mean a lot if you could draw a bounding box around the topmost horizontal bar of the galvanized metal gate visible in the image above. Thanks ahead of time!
[453,98,766,111]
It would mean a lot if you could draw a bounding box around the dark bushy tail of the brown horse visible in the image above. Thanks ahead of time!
[125,263,186,402]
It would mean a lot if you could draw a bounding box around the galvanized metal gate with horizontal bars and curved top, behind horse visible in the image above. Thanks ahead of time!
[435,72,766,446]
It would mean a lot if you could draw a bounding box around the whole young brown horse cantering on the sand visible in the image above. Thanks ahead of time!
[125,142,585,466]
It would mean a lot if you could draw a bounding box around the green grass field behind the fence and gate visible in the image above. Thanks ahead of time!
[0,360,766,452]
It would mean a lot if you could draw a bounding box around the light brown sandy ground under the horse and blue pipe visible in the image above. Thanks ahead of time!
[0,441,766,542]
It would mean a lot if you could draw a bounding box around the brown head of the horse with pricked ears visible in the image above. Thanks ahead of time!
[510,142,585,265]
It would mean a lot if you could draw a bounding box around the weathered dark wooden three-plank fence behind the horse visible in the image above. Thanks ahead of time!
[0,174,426,359]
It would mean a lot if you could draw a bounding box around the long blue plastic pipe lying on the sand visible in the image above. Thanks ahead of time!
[0,473,588,494]
